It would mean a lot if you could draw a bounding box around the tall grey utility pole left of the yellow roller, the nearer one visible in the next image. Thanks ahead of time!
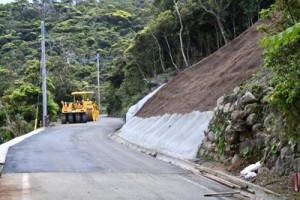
[41,21,48,127]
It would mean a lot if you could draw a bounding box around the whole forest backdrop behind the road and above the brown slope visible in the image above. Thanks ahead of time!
[0,0,273,142]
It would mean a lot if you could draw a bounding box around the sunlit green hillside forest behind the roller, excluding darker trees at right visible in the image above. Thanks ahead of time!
[0,0,148,143]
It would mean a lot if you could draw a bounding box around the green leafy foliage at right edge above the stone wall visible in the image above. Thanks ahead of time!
[260,0,300,140]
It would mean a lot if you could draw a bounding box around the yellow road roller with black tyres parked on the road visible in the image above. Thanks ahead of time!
[61,91,99,124]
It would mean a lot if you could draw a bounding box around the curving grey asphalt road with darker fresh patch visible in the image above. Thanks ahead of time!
[0,117,236,200]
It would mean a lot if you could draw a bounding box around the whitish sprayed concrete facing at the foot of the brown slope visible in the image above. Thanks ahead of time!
[117,111,213,159]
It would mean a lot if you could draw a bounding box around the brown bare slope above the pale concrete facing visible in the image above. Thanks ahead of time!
[137,22,262,117]
